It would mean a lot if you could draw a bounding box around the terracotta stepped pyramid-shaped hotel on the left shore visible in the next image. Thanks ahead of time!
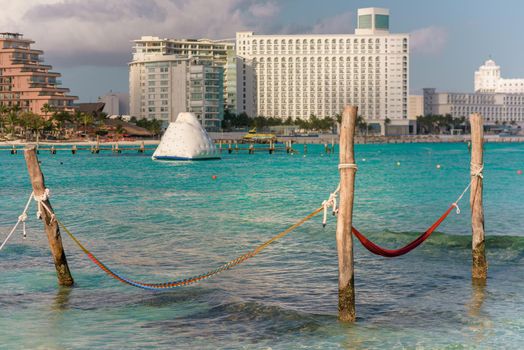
[0,33,78,116]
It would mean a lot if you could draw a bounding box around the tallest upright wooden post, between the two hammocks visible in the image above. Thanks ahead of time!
[336,106,357,322]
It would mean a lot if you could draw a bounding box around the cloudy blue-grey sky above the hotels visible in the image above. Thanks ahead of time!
[4,0,524,102]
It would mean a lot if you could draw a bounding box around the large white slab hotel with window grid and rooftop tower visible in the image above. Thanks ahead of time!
[236,8,413,134]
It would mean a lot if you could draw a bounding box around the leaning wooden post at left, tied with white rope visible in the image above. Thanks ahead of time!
[24,146,74,286]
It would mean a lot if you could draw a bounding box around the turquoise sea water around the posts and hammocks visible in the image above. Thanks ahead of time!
[0,144,524,349]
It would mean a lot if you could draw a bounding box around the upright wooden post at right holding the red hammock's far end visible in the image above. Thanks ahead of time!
[469,113,488,280]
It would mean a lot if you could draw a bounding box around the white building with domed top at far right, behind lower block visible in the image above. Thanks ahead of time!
[475,59,524,94]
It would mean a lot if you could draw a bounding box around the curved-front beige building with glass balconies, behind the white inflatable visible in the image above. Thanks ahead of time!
[129,55,224,130]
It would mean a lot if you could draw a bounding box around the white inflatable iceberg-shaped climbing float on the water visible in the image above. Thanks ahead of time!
[152,112,220,160]
